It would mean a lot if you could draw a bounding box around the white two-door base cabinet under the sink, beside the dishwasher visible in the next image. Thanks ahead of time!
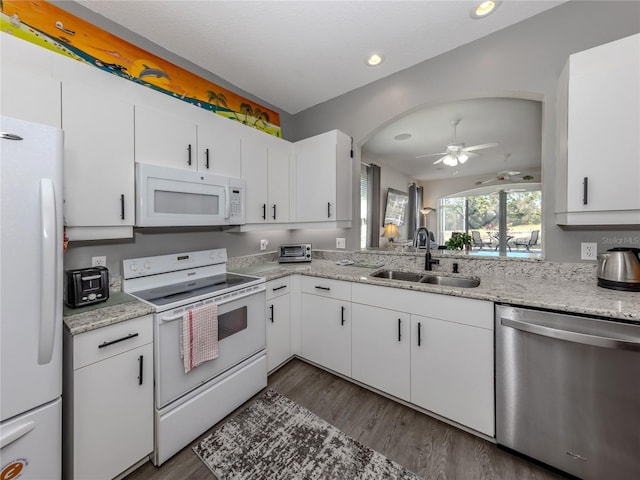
[351,283,494,436]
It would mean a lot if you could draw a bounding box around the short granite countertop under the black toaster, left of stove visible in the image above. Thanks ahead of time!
[63,292,153,335]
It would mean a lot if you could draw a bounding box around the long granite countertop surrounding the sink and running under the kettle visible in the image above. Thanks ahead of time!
[235,259,640,324]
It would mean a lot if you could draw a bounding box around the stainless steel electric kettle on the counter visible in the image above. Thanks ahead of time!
[598,248,640,292]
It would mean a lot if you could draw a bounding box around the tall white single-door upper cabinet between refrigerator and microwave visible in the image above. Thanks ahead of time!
[62,82,135,240]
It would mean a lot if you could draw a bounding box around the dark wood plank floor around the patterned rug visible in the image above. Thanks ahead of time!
[127,359,564,480]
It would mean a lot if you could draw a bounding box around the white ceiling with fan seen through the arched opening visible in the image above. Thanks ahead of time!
[362,98,542,181]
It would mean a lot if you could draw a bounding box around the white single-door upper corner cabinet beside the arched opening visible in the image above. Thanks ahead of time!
[292,130,353,226]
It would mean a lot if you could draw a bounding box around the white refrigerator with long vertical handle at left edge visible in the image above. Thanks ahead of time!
[0,116,63,480]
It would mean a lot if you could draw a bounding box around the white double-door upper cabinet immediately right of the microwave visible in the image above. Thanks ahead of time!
[241,129,291,224]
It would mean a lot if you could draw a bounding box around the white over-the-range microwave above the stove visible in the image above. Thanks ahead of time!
[136,163,245,227]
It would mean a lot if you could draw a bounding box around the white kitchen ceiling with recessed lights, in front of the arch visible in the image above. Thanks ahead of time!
[77,0,563,114]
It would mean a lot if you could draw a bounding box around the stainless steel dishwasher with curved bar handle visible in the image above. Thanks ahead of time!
[495,305,640,480]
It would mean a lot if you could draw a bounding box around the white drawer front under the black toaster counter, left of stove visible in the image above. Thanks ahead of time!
[73,315,153,370]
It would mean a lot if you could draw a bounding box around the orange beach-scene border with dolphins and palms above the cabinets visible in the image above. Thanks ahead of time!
[0,0,282,137]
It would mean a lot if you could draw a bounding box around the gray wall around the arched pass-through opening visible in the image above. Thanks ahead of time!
[294,1,640,262]
